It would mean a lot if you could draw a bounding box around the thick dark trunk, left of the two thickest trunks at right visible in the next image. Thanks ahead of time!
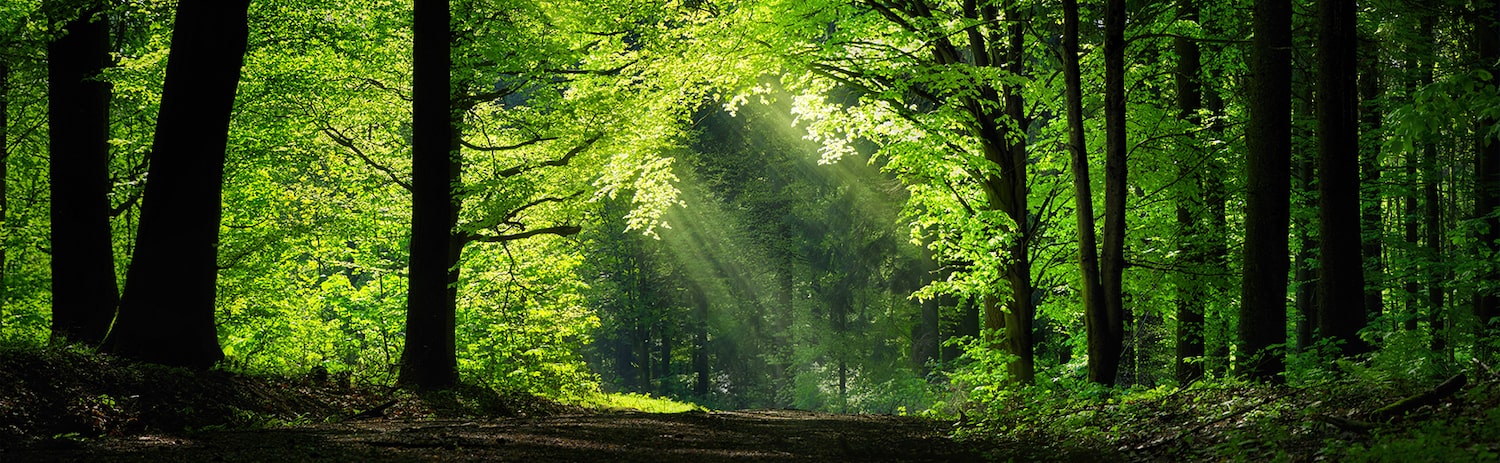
[1239,0,1292,382]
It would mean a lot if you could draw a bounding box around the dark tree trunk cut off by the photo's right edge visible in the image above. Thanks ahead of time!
[1475,1,1500,347]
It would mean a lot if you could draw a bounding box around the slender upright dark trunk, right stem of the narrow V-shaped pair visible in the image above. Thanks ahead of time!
[1089,0,1128,384]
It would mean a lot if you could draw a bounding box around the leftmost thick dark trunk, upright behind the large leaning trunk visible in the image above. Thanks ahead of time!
[47,6,117,345]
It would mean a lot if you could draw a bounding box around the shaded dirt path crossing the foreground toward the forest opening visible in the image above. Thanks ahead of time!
[0,411,980,463]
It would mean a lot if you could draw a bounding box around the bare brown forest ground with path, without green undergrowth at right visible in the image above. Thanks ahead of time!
[0,349,980,463]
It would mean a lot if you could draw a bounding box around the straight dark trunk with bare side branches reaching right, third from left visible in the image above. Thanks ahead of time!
[399,0,462,390]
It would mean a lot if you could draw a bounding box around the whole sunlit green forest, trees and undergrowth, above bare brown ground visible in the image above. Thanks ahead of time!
[0,0,1500,462]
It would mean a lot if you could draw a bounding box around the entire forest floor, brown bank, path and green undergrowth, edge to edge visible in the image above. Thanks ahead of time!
[0,348,1500,463]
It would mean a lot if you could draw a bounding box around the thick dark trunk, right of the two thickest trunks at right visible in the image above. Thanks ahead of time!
[1317,0,1367,355]
